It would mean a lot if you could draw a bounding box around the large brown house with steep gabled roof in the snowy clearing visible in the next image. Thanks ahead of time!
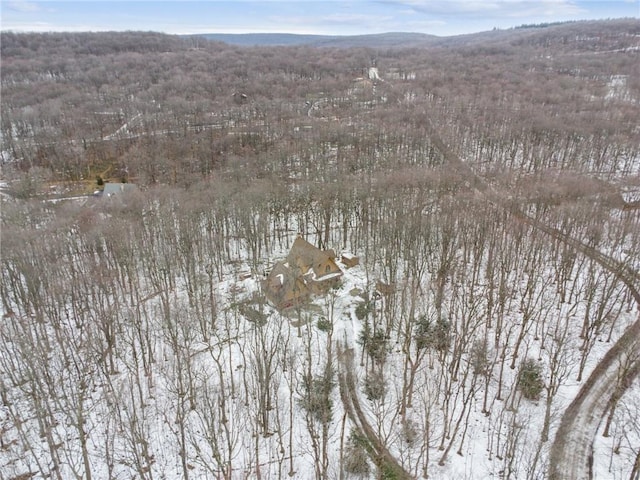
[263,236,342,310]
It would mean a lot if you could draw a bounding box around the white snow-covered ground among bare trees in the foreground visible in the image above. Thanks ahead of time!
[0,210,637,479]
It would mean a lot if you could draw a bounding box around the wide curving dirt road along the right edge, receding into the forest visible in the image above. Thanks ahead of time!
[429,118,640,480]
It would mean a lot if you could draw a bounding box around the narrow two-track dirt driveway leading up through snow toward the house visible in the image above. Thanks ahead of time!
[338,346,413,480]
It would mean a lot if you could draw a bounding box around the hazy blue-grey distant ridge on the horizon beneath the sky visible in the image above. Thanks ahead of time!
[189,32,438,48]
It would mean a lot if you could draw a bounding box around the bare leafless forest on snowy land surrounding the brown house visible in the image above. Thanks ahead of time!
[0,20,640,480]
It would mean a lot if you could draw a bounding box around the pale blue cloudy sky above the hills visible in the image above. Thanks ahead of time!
[0,0,640,36]
